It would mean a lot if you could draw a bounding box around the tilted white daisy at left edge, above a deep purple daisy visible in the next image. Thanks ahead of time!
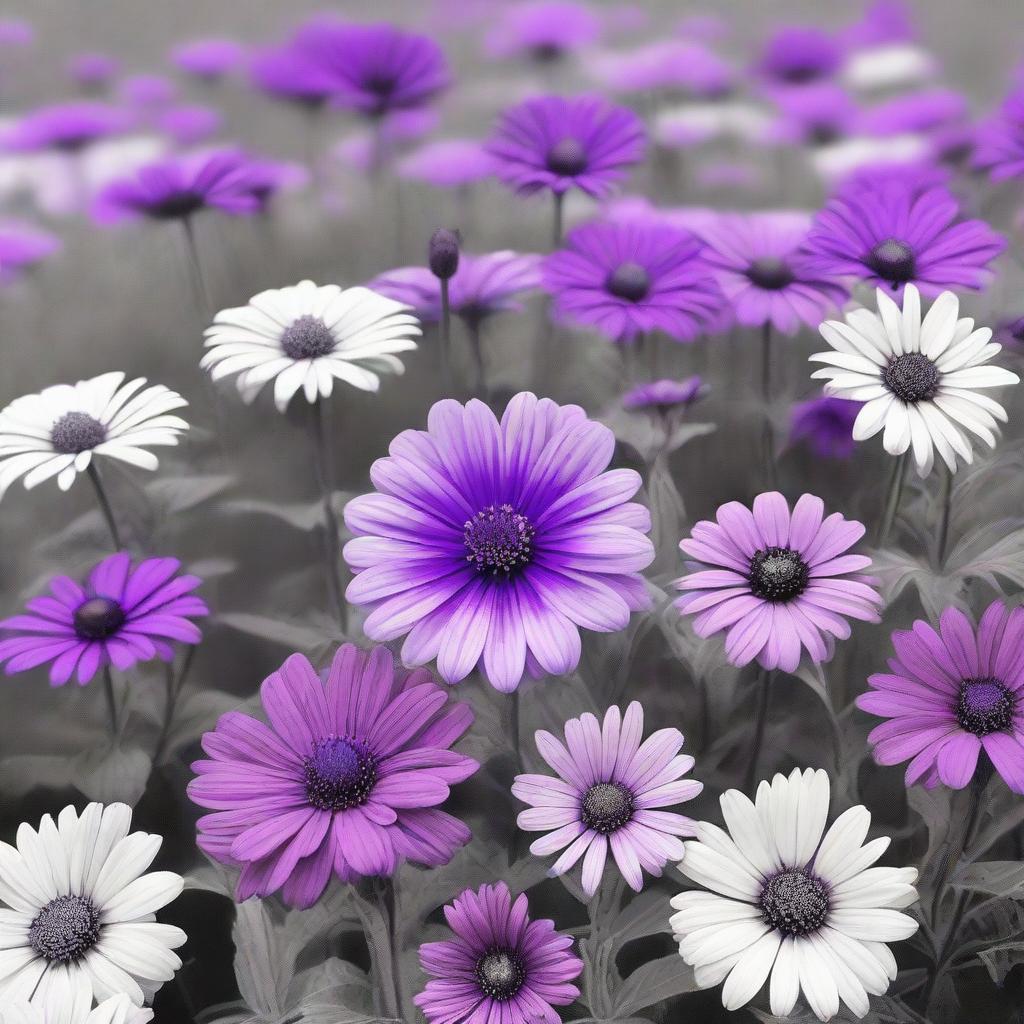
[0,373,188,497]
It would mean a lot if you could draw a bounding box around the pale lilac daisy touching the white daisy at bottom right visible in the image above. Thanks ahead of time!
[512,700,703,898]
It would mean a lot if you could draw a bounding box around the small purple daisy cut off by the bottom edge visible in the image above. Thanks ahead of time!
[413,882,583,1024]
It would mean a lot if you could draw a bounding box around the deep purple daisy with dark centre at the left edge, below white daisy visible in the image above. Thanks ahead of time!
[0,551,210,686]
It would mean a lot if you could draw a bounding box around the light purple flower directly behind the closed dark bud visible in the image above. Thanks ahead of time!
[367,250,541,324]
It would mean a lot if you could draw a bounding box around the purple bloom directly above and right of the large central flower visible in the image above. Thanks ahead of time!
[543,220,723,342]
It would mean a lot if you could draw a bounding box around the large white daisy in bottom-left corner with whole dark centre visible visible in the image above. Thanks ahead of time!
[0,804,185,1007]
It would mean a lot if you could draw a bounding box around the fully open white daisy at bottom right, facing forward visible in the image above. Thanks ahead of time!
[671,768,918,1021]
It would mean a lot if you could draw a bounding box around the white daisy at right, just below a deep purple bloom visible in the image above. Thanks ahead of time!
[811,285,1020,476]
